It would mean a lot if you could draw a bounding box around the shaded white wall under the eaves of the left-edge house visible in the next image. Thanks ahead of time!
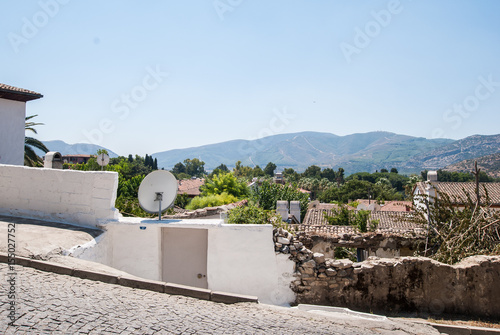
[0,98,26,165]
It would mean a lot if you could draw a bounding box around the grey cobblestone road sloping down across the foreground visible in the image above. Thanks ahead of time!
[0,263,437,335]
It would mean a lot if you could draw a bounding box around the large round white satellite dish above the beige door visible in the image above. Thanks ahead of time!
[138,170,177,220]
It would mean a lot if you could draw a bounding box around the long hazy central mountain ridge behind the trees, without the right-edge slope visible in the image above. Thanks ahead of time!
[152,132,453,173]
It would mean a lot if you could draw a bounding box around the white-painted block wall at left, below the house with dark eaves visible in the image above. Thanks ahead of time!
[0,164,118,226]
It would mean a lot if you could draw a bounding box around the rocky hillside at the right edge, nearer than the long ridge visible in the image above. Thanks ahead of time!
[407,135,500,170]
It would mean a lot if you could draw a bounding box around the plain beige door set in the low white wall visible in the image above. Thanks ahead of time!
[162,227,208,288]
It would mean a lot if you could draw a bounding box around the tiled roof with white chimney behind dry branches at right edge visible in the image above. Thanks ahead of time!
[413,171,500,208]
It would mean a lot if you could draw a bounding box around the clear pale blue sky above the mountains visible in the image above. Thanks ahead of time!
[0,0,500,155]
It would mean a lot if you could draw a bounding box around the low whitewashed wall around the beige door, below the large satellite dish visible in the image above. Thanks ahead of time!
[74,218,295,305]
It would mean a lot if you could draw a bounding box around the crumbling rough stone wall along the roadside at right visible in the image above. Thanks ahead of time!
[274,229,500,319]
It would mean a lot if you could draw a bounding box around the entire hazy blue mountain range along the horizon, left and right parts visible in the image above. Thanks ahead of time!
[40,131,500,174]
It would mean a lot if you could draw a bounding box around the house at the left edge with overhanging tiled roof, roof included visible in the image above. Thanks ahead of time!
[0,83,43,165]
